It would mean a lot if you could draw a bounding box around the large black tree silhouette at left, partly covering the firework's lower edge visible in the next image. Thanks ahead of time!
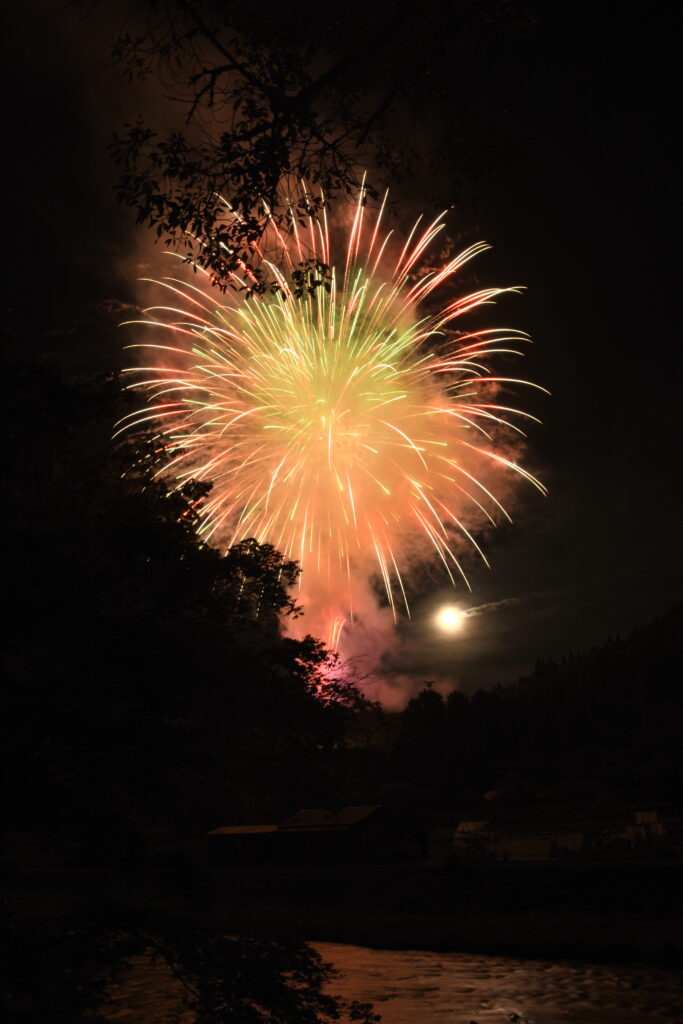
[2,364,368,846]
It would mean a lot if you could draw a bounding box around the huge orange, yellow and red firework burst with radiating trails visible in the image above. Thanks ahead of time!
[121,194,545,646]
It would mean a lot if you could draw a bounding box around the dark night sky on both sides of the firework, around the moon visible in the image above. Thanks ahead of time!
[2,3,682,689]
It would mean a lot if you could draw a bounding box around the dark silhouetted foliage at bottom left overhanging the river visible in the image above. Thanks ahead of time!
[0,903,379,1024]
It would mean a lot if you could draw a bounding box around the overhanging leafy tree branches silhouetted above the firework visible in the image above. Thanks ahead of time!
[113,0,535,290]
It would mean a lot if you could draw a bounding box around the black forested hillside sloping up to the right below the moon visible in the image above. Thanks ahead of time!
[392,607,683,805]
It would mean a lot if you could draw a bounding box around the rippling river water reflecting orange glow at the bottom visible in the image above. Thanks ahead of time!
[101,942,683,1024]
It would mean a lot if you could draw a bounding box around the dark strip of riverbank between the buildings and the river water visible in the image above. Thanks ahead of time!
[3,861,683,966]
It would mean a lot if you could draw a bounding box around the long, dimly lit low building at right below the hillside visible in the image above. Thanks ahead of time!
[451,803,667,862]
